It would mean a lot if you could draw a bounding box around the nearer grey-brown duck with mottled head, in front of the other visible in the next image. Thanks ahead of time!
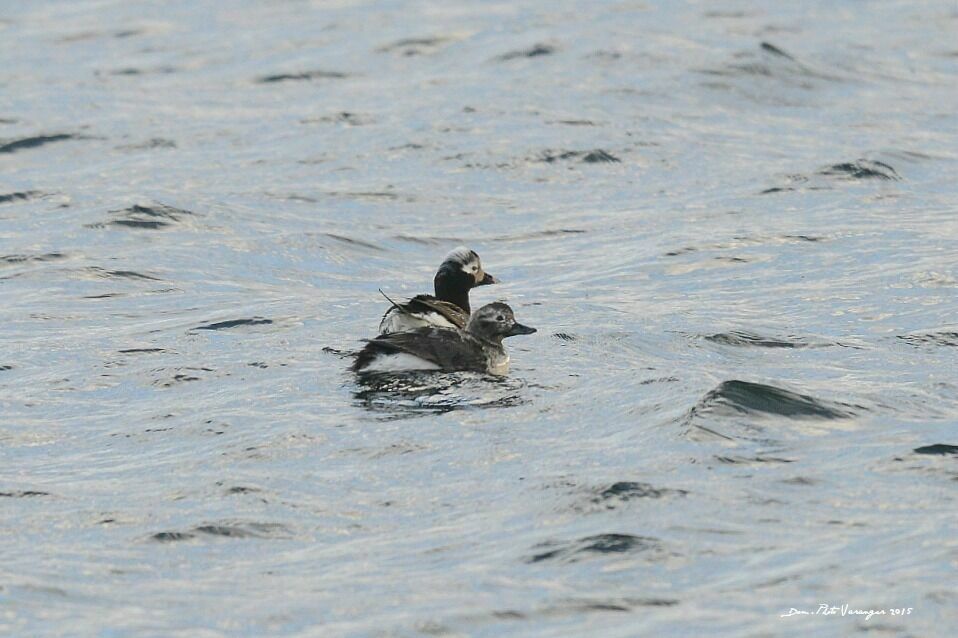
[352,301,536,376]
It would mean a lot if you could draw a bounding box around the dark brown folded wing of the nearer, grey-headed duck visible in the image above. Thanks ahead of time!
[353,328,488,372]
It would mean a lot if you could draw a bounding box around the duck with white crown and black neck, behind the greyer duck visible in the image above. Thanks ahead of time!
[379,246,499,334]
